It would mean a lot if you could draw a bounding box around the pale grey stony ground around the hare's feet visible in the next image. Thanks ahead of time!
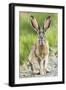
[19,55,58,78]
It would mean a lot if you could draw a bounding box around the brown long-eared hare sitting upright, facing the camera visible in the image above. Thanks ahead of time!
[29,16,51,75]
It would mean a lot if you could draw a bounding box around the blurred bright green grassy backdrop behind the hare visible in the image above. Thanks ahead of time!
[19,12,58,65]
